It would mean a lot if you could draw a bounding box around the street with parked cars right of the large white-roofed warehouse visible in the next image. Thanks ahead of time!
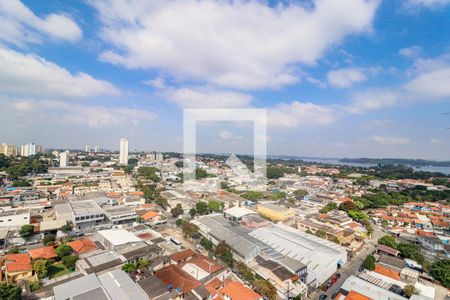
[308,224,384,299]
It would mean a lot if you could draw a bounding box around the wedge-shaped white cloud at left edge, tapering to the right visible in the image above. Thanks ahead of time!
[0,47,120,98]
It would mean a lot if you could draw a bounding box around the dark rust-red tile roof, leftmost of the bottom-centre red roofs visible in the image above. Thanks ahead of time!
[155,265,202,293]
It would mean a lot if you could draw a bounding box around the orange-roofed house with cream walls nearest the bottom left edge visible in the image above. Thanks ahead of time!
[5,253,34,283]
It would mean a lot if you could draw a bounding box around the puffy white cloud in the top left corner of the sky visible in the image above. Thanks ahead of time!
[0,0,82,46]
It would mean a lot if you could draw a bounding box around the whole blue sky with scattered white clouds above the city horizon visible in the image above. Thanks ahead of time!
[0,0,450,159]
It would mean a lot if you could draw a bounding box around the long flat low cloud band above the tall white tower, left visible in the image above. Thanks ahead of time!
[8,100,157,128]
